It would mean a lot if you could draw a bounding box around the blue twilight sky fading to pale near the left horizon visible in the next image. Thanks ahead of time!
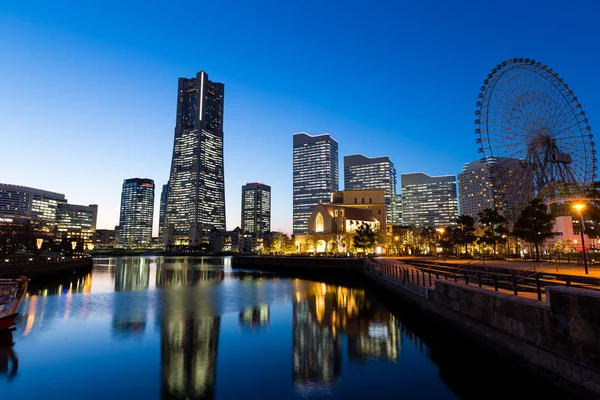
[0,0,600,232]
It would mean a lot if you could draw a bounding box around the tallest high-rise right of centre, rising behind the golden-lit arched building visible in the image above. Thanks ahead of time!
[293,133,339,235]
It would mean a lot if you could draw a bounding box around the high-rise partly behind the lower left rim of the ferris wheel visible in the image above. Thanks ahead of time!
[458,159,501,218]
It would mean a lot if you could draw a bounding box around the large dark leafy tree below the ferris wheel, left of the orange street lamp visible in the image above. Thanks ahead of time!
[514,199,555,260]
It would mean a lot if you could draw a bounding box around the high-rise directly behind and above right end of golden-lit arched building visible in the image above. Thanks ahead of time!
[344,154,396,225]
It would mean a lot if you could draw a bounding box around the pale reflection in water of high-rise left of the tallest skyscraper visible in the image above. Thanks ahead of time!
[113,258,150,337]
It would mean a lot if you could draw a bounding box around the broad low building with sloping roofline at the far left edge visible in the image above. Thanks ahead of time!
[0,183,67,230]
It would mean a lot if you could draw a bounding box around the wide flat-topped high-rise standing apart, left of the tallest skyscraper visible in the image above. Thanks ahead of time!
[118,178,154,247]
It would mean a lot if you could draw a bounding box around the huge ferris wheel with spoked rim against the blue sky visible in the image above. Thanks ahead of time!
[475,58,597,214]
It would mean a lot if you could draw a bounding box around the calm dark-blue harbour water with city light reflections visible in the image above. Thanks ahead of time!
[0,257,567,400]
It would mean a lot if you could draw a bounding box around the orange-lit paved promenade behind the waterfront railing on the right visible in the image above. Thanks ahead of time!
[380,256,600,278]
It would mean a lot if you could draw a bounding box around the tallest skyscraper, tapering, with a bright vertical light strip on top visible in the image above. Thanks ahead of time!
[163,71,225,245]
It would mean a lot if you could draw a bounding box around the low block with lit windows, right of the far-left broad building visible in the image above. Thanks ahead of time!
[55,203,98,248]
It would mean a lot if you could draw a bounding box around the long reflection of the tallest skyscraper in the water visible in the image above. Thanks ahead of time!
[156,266,223,399]
